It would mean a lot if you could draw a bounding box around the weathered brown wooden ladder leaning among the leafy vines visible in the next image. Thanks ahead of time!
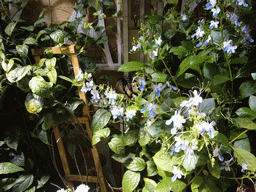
[31,45,107,192]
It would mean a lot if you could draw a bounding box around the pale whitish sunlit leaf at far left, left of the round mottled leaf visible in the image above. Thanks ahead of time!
[6,65,31,83]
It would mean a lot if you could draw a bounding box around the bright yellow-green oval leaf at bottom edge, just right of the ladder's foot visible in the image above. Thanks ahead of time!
[122,170,140,192]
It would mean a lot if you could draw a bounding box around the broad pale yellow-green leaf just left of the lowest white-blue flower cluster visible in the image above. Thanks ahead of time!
[153,151,180,172]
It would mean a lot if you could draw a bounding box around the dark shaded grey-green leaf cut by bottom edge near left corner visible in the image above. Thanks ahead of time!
[13,175,34,192]
